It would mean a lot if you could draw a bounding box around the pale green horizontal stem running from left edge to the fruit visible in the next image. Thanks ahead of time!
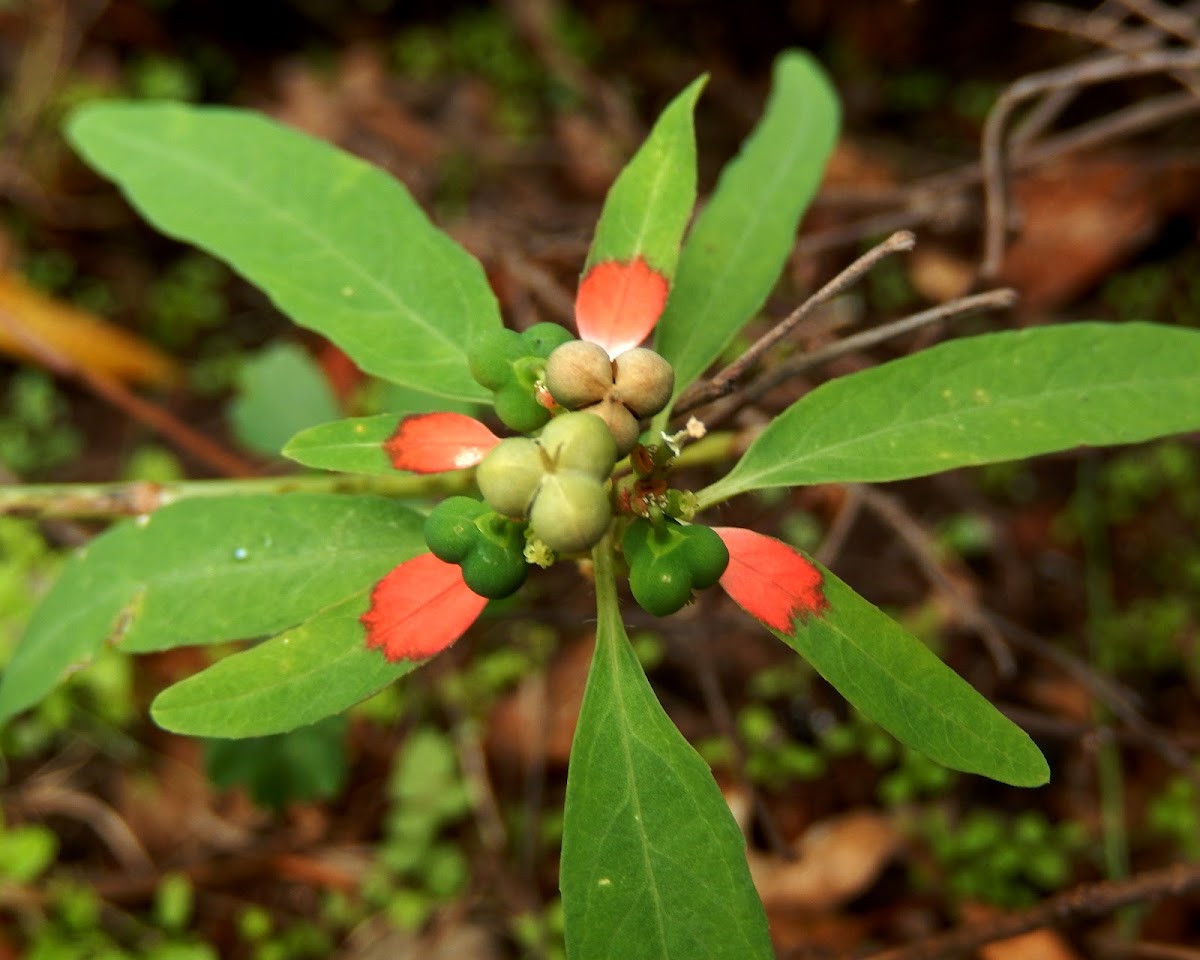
[0,470,469,520]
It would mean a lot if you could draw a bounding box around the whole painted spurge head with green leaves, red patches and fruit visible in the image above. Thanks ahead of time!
[0,53,1200,960]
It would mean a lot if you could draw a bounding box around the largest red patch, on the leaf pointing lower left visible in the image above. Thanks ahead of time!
[360,553,487,661]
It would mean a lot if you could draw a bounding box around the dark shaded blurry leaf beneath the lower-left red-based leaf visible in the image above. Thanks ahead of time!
[204,716,349,810]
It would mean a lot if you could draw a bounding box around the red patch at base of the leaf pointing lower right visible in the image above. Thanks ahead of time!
[713,527,828,634]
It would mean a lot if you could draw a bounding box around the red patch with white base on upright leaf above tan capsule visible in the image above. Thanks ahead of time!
[575,257,668,358]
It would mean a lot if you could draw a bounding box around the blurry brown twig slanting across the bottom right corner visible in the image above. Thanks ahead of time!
[866,864,1200,960]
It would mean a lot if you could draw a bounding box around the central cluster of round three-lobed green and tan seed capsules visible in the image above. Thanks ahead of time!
[425,324,728,616]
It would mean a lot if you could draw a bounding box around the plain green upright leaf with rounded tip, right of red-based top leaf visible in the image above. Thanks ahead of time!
[654,52,839,412]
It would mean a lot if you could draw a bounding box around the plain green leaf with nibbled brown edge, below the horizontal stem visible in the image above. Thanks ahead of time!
[0,493,425,721]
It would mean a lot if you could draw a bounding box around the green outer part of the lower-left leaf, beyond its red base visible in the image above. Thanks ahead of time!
[150,589,420,737]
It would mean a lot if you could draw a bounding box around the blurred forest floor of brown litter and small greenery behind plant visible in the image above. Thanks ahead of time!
[0,0,1200,960]
